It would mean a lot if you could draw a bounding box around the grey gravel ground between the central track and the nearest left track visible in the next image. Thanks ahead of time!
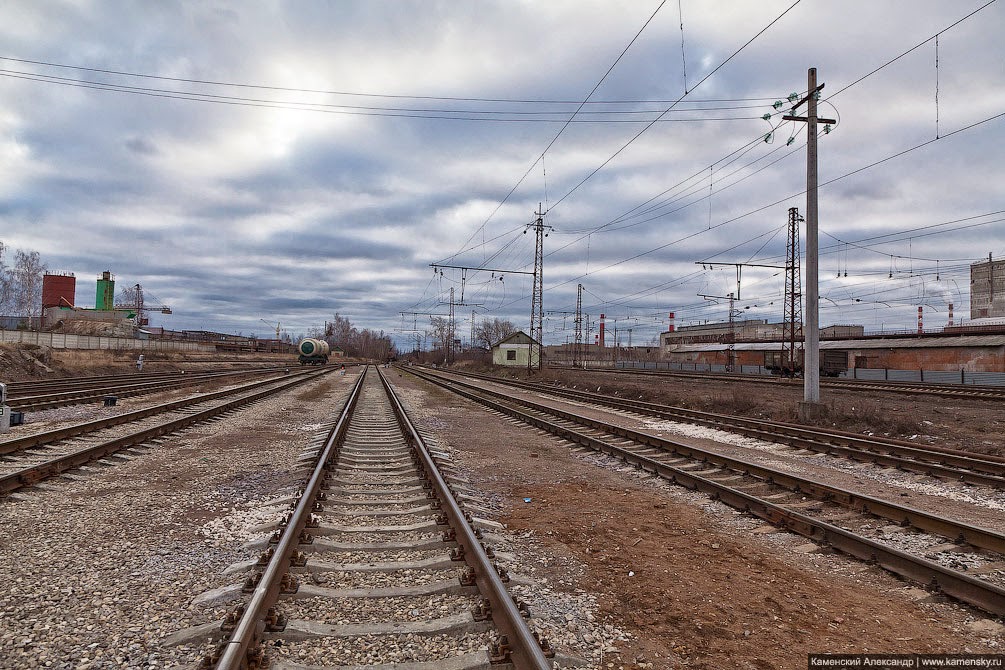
[0,376,352,669]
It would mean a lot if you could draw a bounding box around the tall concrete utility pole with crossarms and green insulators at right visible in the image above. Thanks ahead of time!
[782,67,837,409]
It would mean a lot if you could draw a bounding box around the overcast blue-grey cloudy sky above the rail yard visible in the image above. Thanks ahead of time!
[0,0,1005,348]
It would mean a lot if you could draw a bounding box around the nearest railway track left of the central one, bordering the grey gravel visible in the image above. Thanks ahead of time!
[0,370,334,495]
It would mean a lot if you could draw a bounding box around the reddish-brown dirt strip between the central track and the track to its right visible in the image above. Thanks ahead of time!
[387,367,1005,670]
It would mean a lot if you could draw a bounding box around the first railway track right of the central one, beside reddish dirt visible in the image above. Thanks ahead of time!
[405,369,1005,615]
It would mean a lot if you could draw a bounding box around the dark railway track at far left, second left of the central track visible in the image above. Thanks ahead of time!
[8,367,284,412]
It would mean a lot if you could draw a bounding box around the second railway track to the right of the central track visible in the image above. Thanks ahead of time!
[424,372,1005,490]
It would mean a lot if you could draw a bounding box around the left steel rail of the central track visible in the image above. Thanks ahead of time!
[214,370,366,670]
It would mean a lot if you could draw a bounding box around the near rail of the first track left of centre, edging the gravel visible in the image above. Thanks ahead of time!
[0,375,331,495]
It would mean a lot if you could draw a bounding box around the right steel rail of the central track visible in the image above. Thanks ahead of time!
[377,369,552,670]
